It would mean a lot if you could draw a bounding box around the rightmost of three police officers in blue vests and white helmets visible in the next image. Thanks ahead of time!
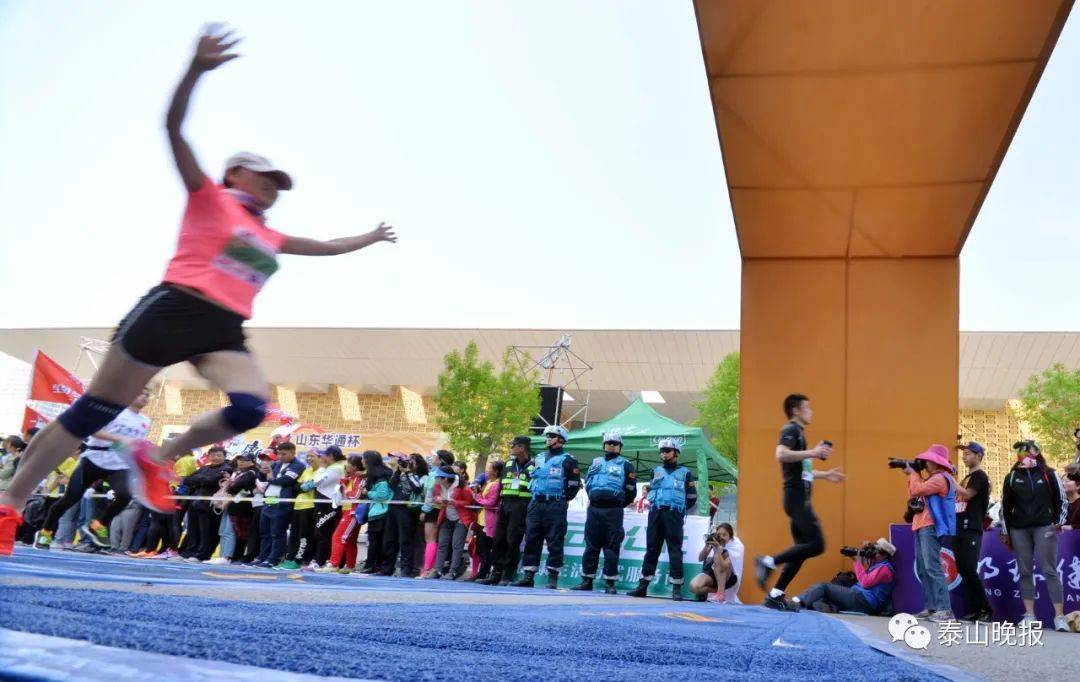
[626,438,698,601]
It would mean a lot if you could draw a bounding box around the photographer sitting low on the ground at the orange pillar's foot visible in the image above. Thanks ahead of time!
[792,537,896,616]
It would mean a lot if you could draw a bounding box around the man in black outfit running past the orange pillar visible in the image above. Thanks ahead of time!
[754,393,845,611]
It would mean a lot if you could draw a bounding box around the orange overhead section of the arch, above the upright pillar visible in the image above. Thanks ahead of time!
[696,0,1072,258]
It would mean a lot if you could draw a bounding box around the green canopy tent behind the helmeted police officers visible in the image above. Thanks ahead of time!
[532,398,739,514]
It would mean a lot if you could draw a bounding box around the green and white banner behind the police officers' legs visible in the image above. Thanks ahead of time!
[538,509,708,596]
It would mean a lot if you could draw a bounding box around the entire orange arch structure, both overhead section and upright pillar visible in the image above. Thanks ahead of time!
[694,0,1072,598]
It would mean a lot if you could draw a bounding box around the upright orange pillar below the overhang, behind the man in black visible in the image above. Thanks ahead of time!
[738,257,959,601]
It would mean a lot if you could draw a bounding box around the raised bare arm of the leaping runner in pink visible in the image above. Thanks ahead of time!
[165,26,240,191]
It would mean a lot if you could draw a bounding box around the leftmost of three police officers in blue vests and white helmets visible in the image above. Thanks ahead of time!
[513,425,581,589]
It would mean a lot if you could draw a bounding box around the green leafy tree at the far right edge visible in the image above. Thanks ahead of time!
[1020,363,1080,463]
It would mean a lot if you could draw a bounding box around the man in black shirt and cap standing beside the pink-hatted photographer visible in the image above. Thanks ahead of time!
[953,441,991,621]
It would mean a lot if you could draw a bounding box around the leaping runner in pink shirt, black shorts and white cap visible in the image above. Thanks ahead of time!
[0,28,397,553]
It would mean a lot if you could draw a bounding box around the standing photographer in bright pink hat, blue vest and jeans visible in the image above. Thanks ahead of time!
[889,443,956,623]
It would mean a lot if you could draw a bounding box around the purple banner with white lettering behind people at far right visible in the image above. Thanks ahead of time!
[889,523,1080,629]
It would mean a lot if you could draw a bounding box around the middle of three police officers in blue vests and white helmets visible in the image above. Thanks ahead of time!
[570,431,637,594]
